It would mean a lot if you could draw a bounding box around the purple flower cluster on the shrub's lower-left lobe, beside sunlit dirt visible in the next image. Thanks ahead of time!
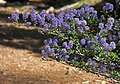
[41,37,77,60]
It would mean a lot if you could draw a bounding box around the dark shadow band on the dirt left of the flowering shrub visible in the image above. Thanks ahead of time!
[0,11,48,53]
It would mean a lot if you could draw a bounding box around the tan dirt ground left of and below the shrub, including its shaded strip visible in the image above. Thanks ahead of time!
[0,2,117,84]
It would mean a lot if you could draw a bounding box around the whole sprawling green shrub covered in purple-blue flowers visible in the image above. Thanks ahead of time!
[9,0,120,78]
